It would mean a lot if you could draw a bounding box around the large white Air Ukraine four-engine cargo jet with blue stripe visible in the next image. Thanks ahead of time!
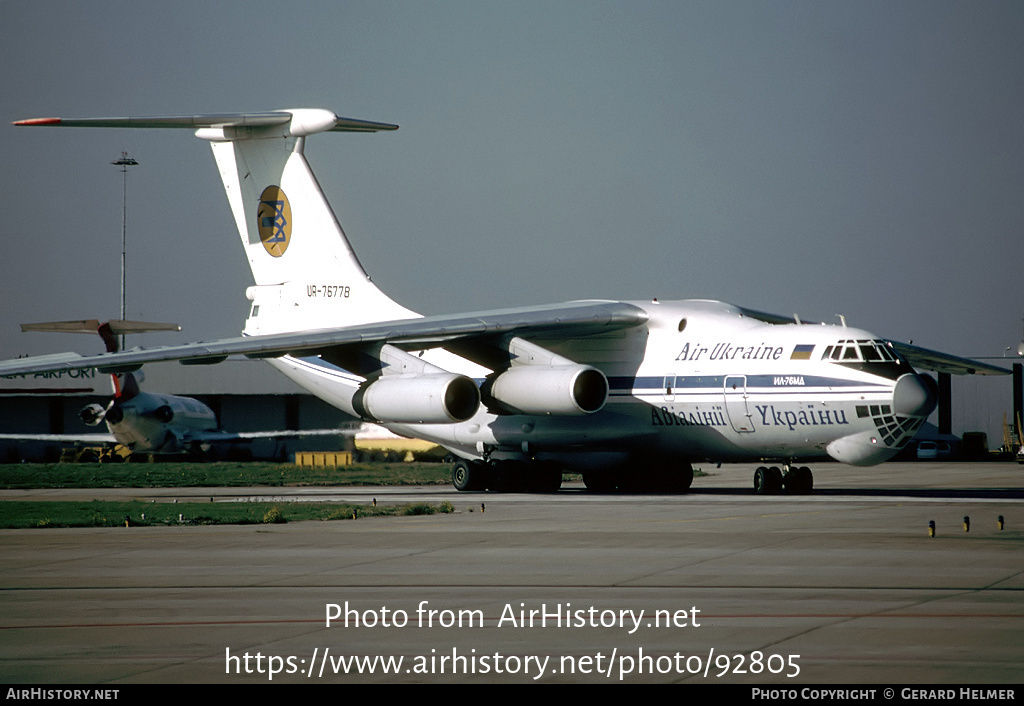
[0,110,1007,493]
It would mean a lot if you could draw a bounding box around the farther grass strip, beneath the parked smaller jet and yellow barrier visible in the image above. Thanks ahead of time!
[0,461,452,489]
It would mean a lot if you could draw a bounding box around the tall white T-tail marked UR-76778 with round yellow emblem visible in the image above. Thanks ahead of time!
[15,109,419,335]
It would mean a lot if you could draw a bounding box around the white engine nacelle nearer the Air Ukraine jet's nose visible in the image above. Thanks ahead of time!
[487,365,608,415]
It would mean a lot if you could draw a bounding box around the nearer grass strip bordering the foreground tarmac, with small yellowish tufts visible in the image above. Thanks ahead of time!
[0,500,455,530]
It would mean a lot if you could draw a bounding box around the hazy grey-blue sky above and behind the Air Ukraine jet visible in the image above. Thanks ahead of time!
[0,0,1024,430]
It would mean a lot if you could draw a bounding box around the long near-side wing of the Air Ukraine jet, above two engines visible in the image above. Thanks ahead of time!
[0,301,647,375]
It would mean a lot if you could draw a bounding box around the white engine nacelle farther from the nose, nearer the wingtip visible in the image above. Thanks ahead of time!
[352,373,480,424]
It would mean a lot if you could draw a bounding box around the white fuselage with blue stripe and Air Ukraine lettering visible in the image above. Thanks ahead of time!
[266,300,935,470]
